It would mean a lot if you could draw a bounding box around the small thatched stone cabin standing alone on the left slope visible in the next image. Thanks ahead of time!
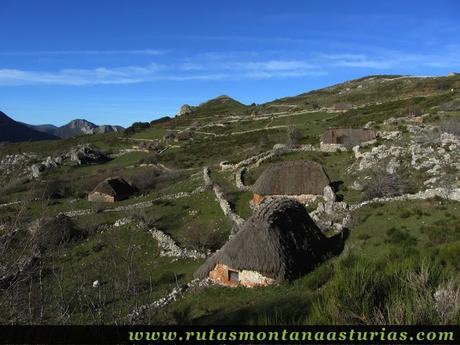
[88,177,137,202]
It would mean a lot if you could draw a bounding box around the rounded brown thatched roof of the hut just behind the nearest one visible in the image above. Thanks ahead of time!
[253,161,330,195]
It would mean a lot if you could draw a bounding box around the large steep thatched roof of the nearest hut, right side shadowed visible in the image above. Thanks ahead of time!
[195,199,330,281]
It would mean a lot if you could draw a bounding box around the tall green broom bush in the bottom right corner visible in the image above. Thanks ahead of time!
[305,254,452,324]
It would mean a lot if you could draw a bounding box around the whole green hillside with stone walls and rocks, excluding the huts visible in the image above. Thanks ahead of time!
[0,76,460,324]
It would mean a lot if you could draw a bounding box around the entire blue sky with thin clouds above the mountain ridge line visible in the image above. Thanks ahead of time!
[0,0,460,125]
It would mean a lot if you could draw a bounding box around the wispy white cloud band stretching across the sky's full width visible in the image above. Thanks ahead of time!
[0,46,460,86]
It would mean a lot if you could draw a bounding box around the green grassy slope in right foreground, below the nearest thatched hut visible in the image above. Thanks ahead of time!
[149,200,460,324]
